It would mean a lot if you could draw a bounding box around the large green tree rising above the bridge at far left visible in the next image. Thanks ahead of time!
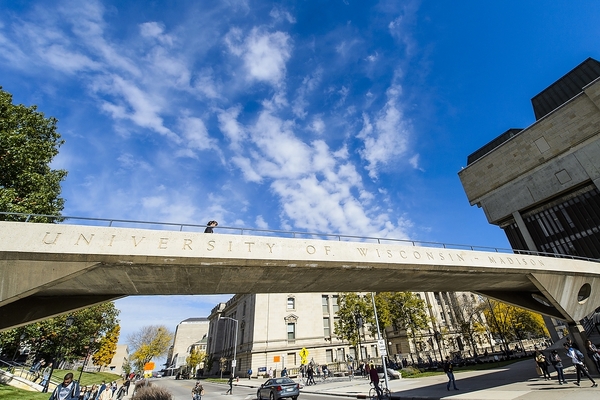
[0,87,67,222]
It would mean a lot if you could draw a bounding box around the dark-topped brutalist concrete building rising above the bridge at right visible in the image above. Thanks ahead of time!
[459,58,600,339]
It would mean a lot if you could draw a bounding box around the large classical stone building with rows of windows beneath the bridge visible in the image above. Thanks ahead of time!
[207,292,491,376]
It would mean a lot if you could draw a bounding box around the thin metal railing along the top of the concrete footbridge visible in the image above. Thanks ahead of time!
[0,211,600,262]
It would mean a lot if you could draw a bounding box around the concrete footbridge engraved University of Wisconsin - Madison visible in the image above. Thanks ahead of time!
[0,222,600,330]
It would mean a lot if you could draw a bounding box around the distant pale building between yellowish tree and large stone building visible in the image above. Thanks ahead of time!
[167,318,209,373]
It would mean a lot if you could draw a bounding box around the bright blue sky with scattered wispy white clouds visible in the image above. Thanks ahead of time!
[0,0,600,344]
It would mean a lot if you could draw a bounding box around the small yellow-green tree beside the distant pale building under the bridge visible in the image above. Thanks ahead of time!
[127,325,173,371]
